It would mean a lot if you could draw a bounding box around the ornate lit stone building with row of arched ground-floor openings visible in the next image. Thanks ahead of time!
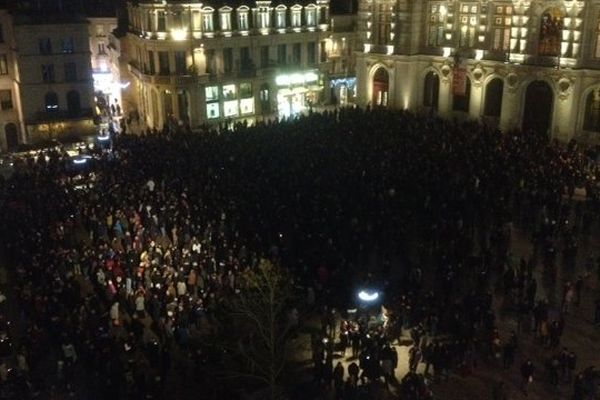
[356,0,600,140]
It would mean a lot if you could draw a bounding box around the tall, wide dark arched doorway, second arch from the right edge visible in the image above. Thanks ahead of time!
[522,81,554,134]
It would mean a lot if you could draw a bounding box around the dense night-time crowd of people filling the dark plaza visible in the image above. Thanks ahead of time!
[0,108,600,400]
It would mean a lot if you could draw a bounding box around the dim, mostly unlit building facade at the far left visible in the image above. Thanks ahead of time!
[13,14,96,143]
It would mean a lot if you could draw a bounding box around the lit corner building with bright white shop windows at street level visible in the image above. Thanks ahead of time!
[123,0,352,129]
